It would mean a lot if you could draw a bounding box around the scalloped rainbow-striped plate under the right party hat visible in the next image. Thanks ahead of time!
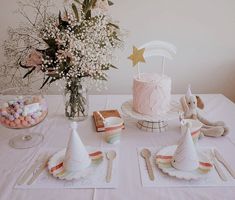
[156,145,213,180]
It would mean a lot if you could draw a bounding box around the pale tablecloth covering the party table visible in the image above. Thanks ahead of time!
[0,94,235,200]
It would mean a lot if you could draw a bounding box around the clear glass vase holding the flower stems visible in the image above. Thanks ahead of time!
[64,79,89,121]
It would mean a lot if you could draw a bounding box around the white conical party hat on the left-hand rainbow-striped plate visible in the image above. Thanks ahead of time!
[63,122,91,172]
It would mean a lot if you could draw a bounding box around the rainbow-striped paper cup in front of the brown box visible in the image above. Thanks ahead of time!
[104,117,124,144]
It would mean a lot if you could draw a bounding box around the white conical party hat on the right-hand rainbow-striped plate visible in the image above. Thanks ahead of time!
[171,123,199,171]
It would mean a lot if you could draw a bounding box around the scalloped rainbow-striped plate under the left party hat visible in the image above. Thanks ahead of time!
[48,149,103,180]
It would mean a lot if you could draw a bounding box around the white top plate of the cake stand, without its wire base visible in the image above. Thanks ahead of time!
[121,100,182,122]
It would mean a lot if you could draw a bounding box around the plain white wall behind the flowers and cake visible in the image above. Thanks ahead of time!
[0,0,235,101]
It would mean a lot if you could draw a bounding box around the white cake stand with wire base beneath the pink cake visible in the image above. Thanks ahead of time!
[121,100,182,132]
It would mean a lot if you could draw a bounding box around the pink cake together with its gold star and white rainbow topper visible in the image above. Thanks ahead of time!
[129,41,176,116]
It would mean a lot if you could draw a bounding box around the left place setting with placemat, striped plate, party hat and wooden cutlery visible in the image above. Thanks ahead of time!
[15,122,119,189]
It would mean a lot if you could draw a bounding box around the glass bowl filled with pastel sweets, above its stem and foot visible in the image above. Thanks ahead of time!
[0,88,48,129]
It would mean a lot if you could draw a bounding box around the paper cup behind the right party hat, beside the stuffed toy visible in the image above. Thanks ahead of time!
[180,119,202,143]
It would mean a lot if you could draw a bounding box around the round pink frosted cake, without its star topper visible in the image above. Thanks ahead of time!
[133,73,171,116]
